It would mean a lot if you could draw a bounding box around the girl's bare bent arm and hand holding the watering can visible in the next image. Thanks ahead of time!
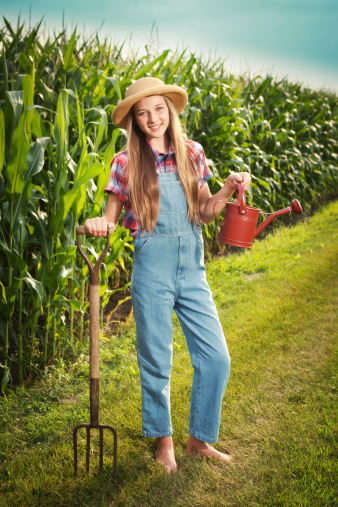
[198,173,251,224]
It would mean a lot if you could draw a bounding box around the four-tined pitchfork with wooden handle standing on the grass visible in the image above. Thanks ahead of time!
[73,226,117,481]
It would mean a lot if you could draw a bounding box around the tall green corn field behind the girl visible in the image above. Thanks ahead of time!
[0,18,338,390]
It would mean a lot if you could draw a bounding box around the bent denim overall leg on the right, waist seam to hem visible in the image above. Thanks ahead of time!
[174,235,230,443]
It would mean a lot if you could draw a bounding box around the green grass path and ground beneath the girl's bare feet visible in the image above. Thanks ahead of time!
[0,202,338,507]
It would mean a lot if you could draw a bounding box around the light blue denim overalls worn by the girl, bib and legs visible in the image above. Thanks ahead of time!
[131,173,230,443]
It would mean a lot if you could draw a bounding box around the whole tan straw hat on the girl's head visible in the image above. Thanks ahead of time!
[113,77,188,129]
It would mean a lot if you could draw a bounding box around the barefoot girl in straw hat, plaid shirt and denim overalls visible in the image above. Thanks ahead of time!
[85,77,250,473]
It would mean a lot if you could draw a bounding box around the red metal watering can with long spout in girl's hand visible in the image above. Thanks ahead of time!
[214,182,303,248]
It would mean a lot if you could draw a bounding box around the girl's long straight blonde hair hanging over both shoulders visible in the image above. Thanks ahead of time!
[127,97,199,232]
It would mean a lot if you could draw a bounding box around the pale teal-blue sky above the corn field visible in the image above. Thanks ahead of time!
[0,0,338,93]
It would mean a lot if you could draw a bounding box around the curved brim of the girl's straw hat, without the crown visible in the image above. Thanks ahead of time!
[112,85,188,129]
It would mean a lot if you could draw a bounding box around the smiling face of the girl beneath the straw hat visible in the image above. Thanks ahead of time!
[134,95,169,145]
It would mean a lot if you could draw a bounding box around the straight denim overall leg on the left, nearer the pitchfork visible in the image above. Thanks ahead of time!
[131,237,178,437]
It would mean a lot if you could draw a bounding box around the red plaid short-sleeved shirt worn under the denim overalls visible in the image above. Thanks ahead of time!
[105,140,212,238]
